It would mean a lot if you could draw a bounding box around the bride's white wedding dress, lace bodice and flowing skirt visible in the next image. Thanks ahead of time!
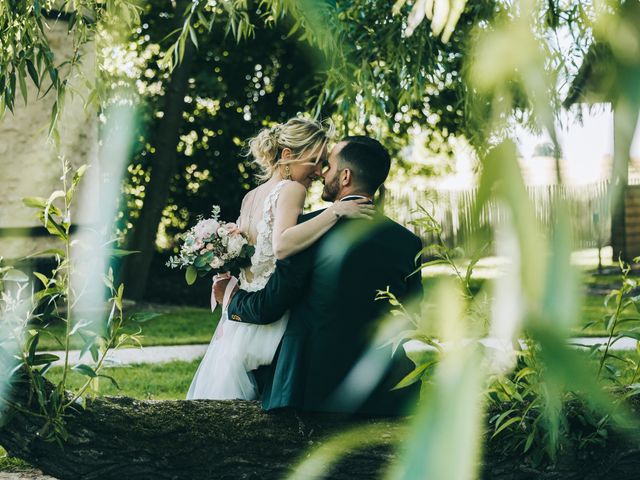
[187,180,290,400]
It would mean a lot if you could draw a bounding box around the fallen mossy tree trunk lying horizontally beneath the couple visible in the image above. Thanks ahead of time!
[0,382,640,480]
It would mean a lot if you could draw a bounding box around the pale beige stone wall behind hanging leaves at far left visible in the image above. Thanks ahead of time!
[0,20,98,258]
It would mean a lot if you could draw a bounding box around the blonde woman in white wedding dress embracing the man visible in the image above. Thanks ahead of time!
[187,118,373,400]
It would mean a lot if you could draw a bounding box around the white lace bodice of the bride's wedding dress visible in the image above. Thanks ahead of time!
[240,180,291,292]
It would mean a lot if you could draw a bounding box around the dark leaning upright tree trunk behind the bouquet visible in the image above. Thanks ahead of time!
[122,0,195,300]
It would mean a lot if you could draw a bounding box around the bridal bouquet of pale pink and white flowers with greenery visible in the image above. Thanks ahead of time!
[167,205,255,285]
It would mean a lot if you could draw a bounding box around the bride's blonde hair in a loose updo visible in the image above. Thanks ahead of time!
[248,117,335,180]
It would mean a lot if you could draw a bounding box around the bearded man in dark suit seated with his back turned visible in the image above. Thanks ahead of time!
[214,136,422,415]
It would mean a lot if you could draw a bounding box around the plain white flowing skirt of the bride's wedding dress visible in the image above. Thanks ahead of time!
[187,302,289,400]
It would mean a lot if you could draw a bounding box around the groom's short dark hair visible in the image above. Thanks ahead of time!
[338,135,391,195]
